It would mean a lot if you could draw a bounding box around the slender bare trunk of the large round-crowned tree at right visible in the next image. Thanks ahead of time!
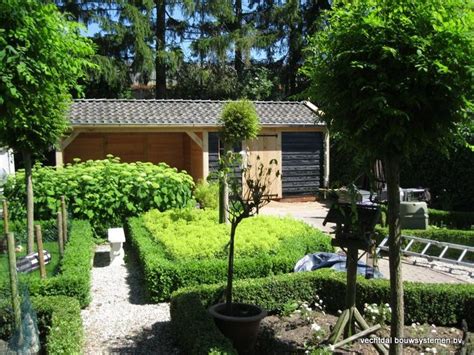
[385,156,404,355]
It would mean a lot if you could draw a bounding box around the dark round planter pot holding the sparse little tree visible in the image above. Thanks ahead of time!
[208,303,267,355]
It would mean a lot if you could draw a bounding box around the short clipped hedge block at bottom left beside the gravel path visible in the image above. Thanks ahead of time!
[32,296,84,355]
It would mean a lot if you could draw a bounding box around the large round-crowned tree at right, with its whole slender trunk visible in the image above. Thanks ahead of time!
[303,0,474,354]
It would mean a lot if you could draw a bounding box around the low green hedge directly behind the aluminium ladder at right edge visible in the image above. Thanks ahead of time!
[377,228,474,261]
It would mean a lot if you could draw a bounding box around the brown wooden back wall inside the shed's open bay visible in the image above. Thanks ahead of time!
[64,132,202,180]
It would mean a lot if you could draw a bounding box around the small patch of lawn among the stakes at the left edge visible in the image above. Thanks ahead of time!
[0,242,60,284]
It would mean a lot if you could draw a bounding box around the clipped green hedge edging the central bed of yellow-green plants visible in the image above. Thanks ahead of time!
[127,213,333,302]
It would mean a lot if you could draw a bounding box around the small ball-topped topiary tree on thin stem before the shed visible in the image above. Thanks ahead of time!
[219,100,260,223]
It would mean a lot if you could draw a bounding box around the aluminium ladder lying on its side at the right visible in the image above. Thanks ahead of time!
[376,235,474,276]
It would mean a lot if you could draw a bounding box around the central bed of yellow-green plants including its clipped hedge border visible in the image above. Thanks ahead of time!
[128,209,333,302]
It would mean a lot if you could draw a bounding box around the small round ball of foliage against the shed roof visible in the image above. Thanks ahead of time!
[219,100,260,145]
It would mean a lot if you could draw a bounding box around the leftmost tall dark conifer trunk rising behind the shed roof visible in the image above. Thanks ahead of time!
[155,0,166,99]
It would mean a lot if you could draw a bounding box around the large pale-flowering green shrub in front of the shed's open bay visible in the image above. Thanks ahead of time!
[5,158,194,235]
